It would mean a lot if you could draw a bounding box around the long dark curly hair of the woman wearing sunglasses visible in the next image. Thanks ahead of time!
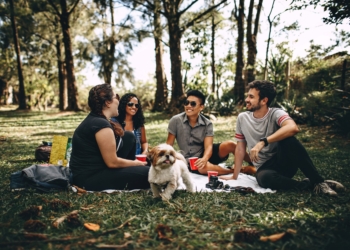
[117,93,145,129]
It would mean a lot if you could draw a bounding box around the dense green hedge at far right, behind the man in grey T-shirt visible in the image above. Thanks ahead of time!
[276,43,350,135]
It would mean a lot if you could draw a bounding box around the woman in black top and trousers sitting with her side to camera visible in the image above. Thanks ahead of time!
[69,84,149,191]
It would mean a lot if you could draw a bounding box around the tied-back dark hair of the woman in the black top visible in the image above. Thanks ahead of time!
[88,83,124,137]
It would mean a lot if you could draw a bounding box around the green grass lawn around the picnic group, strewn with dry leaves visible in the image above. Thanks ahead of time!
[0,110,350,249]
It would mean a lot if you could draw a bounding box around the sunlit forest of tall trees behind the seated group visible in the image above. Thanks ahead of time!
[0,0,350,136]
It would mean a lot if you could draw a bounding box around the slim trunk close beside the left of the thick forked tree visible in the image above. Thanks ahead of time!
[56,36,68,111]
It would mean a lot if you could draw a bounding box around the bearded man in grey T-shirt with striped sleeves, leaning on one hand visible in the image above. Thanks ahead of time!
[222,80,344,196]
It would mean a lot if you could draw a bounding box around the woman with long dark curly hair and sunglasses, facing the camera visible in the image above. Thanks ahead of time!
[112,93,148,155]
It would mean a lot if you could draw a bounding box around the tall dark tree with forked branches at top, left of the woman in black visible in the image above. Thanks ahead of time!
[47,0,81,111]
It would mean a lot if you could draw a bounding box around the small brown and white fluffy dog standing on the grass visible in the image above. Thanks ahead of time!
[147,143,194,200]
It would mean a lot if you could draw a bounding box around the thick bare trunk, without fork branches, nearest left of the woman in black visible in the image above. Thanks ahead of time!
[60,0,81,111]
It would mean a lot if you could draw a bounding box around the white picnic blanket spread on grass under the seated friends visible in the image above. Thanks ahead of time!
[72,173,276,193]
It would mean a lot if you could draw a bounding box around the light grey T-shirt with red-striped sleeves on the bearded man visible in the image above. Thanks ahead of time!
[235,108,292,168]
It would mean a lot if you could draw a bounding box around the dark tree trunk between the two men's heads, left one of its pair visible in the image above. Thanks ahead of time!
[233,0,245,103]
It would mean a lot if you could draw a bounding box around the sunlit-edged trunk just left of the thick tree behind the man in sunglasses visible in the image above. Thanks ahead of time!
[153,0,168,111]
